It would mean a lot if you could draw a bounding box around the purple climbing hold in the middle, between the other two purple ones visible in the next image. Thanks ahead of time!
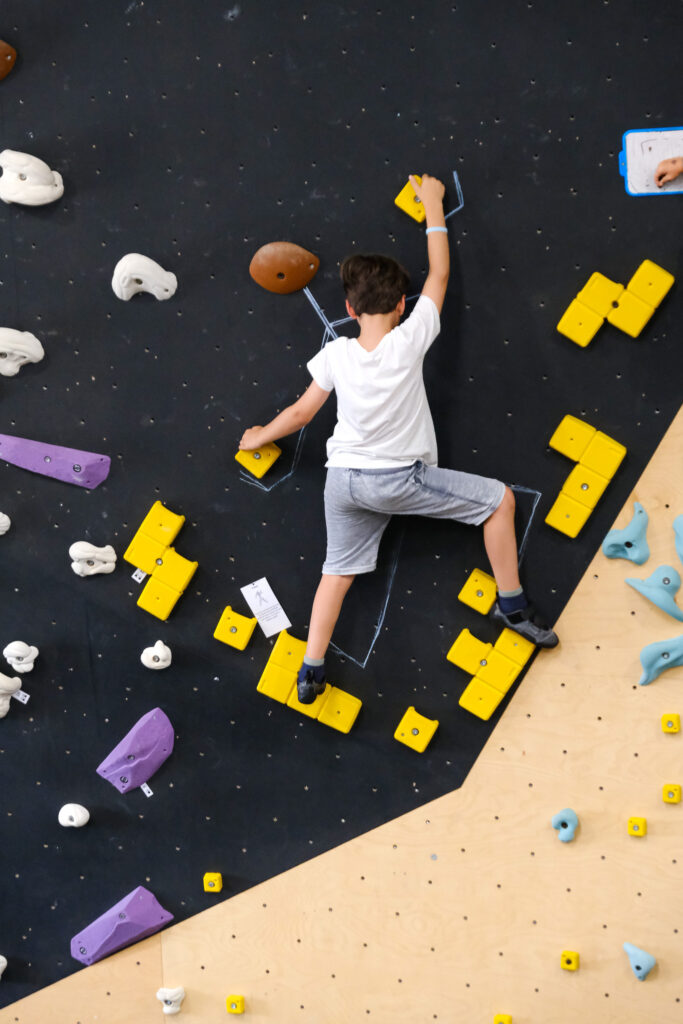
[97,708,173,793]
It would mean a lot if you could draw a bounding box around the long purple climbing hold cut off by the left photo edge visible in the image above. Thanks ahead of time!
[0,434,112,490]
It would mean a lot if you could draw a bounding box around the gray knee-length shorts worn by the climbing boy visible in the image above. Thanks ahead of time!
[323,462,505,575]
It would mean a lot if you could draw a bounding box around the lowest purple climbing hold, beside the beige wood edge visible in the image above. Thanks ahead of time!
[71,886,173,964]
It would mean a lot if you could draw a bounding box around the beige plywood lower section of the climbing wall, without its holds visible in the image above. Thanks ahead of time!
[5,410,683,1024]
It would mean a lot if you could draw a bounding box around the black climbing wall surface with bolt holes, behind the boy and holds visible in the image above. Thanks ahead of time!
[0,0,683,1004]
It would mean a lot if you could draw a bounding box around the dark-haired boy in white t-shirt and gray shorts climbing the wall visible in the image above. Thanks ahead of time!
[240,174,558,703]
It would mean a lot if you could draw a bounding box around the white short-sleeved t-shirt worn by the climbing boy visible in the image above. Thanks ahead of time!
[307,295,440,469]
